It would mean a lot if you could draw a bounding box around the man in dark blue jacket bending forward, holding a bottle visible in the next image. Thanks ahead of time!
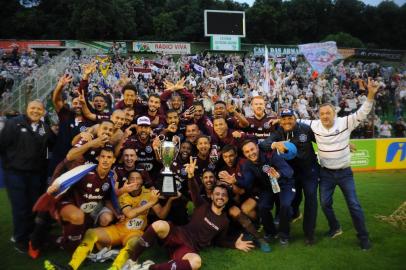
[238,140,295,245]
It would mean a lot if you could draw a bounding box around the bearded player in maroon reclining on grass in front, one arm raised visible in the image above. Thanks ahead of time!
[120,157,254,270]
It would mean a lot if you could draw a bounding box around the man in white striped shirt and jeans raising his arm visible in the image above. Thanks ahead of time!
[300,79,379,250]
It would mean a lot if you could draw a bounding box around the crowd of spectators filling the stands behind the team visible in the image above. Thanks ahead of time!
[0,47,406,138]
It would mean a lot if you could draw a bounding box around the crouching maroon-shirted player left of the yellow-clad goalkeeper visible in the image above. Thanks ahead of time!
[47,147,116,248]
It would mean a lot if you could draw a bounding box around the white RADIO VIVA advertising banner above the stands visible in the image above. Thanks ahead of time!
[133,41,190,54]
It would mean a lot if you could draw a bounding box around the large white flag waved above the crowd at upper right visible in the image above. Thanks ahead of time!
[299,41,338,74]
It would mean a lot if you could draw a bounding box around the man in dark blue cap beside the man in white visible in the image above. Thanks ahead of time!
[259,109,319,245]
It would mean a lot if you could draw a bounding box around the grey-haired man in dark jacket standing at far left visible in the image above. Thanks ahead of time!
[0,100,53,252]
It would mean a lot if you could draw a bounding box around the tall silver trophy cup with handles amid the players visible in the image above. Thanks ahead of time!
[158,136,179,196]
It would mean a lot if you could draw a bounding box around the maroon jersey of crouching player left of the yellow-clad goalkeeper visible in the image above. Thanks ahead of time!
[60,169,112,214]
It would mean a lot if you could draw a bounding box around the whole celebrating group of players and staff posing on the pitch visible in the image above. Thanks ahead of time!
[0,64,379,269]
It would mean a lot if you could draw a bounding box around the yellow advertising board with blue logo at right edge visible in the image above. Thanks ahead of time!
[376,138,406,170]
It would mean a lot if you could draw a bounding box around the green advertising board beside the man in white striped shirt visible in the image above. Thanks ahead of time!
[351,139,376,171]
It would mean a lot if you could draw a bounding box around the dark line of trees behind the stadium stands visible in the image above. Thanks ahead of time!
[0,0,406,49]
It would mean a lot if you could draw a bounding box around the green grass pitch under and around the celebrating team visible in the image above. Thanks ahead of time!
[0,171,406,270]
